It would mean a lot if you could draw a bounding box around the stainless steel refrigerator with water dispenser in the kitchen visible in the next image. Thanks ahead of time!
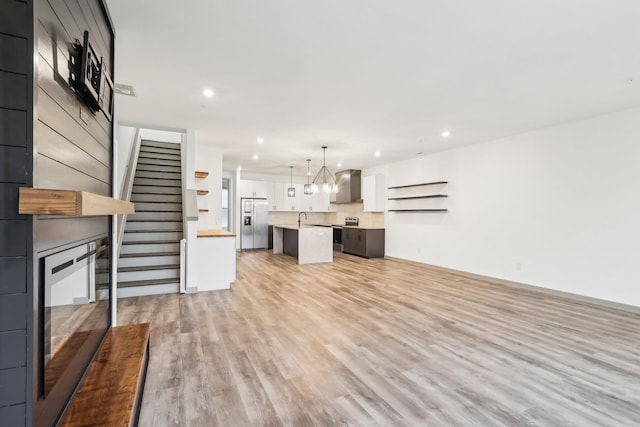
[240,198,269,250]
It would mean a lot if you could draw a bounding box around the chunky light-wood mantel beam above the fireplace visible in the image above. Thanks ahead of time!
[18,187,135,216]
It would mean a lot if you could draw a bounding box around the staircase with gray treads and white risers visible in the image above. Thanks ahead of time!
[118,140,182,298]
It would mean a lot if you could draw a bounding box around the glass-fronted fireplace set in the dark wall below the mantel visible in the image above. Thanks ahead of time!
[34,236,110,425]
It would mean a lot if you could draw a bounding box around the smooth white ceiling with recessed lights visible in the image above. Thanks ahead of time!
[107,0,640,176]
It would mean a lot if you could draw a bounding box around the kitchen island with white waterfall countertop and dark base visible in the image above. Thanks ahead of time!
[273,224,333,264]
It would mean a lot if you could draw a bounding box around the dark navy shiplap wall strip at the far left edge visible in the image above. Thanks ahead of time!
[0,0,33,426]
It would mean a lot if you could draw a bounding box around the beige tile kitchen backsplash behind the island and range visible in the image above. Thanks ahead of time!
[269,203,384,227]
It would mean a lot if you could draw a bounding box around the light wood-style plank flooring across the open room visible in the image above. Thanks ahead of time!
[118,251,640,427]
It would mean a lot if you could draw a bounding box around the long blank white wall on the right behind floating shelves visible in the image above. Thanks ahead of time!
[366,108,640,306]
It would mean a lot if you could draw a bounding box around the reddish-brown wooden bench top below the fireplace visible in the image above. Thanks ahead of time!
[58,323,149,427]
